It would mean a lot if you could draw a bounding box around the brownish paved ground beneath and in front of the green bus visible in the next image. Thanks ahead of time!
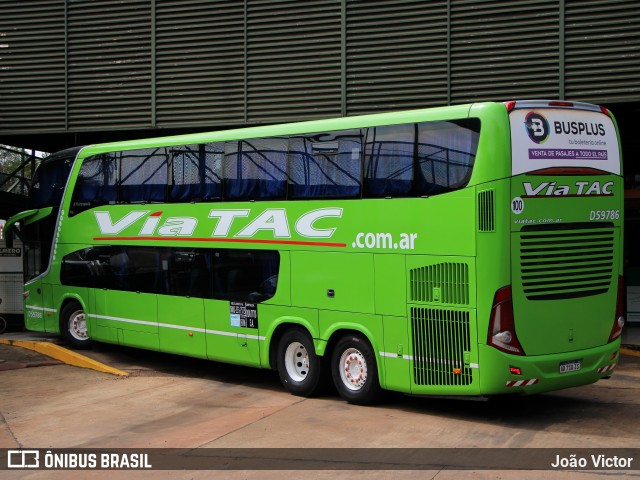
[0,328,640,480]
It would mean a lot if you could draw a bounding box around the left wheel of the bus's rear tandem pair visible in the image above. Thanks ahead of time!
[276,328,323,397]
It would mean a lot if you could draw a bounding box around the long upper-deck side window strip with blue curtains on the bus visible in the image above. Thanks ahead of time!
[70,119,480,215]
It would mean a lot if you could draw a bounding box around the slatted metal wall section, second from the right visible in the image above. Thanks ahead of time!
[451,0,560,103]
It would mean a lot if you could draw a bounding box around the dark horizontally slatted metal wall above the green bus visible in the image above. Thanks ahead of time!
[0,0,640,139]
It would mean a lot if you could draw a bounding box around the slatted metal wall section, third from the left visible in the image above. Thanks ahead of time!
[155,0,245,126]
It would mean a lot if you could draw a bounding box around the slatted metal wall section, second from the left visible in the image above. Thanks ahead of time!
[67,0,152,130]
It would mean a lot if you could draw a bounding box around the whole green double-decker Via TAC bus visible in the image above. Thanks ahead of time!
[5,101,624,404]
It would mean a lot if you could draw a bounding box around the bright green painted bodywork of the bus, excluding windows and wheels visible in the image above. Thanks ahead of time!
[17,103,622,395]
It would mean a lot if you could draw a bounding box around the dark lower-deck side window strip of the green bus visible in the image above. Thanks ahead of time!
[61,245,280,302]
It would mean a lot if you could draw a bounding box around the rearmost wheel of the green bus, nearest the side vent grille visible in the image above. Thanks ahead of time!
[331,333,382,405]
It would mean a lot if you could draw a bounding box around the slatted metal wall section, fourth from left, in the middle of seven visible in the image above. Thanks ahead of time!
[246,0,341,123]
